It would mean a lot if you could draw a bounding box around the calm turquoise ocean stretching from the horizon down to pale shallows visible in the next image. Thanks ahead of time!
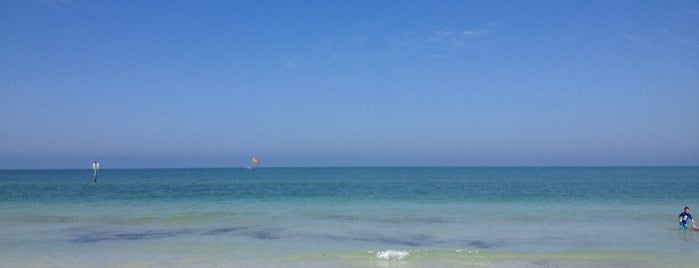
[0,167,699,267]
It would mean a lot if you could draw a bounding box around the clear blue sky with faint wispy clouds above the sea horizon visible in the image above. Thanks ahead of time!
[0,0,699,168]
